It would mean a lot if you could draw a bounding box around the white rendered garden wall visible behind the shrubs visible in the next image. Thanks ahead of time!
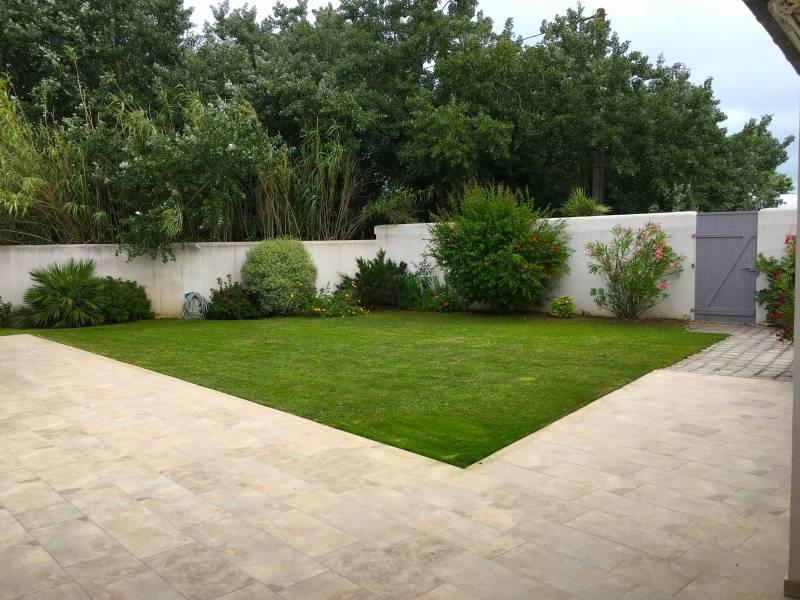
[0,209,796,320]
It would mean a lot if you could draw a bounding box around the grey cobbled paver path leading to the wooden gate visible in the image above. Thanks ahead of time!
[672,323,794,381]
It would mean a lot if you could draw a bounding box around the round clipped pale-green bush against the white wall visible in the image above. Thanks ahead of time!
[242,239,317,316]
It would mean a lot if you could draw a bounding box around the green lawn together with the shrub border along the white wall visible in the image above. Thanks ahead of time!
[0,185,722,467]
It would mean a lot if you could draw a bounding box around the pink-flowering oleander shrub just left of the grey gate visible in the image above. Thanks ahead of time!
[586,223,683,319]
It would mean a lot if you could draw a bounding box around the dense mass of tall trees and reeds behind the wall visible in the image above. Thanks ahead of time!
[0,0,791,254]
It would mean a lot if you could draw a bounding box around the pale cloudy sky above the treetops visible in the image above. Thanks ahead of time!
[184,0,800,188]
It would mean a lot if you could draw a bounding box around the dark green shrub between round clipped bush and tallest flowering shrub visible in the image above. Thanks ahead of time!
[337,249,408,307]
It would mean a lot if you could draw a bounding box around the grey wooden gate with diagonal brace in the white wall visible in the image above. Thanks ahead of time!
[694,212,758,323]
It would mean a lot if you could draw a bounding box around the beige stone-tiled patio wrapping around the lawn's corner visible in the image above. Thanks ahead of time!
[0,336,791,600]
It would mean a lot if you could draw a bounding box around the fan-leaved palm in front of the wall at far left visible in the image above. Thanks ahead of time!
[25,258,106,328]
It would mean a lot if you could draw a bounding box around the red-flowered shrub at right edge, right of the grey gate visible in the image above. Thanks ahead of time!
[756,235,797,341]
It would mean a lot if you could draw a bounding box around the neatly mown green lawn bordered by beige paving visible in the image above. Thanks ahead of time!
[1,312,724,467]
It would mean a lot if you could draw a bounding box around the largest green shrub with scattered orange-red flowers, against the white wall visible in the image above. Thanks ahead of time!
[431,185,571,311]
